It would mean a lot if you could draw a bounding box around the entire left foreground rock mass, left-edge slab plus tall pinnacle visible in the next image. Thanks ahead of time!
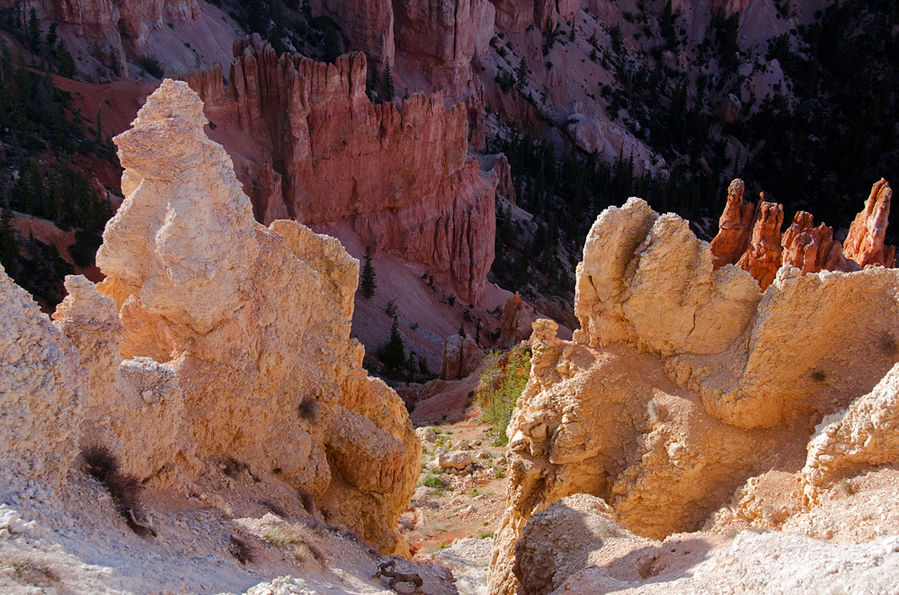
[0,80,420,553]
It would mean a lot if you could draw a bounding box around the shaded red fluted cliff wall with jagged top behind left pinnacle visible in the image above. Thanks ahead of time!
[190,37,496,300]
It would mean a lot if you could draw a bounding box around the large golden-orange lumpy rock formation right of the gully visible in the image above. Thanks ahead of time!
[491,198,899,593]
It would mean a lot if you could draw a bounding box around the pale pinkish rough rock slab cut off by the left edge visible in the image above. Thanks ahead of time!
[0,266,90,502]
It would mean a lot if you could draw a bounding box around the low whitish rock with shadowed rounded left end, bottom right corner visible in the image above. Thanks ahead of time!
[520,494,899,594]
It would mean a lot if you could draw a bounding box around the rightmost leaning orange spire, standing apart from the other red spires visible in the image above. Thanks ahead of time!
[843,178,896,267]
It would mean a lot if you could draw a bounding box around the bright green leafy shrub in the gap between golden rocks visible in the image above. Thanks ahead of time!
[478,346,531,446]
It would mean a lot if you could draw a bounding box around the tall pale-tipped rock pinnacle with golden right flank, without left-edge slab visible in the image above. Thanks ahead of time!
[97,80,420,551]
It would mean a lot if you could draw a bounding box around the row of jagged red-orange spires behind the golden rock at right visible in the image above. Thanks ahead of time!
[710,179,896,291]
